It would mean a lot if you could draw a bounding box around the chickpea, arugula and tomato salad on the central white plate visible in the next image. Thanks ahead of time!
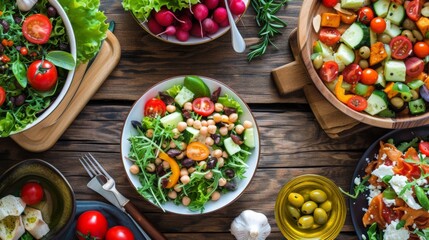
[127,76,256,212]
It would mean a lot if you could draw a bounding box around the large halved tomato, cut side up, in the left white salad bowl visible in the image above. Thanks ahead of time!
[22,14,52,44]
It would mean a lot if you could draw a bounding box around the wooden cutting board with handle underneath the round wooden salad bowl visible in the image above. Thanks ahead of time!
[272,29,370,138]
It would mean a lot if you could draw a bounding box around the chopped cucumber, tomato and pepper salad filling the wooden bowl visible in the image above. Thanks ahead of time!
[312,0,429,117]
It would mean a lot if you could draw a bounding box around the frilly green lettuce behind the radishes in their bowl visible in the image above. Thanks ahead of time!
[122,0,199,21]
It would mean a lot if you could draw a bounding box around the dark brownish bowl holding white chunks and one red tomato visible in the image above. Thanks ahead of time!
[0,159,75,239]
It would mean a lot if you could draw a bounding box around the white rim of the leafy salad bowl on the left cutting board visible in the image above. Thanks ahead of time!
[10,0,76,135]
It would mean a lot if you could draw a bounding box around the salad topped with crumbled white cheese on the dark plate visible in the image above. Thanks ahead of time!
[346,137,429,240]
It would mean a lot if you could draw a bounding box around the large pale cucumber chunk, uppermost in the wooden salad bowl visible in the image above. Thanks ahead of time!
[340,22,370,49]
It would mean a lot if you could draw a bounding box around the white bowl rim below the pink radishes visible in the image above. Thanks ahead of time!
[133,0,250,45]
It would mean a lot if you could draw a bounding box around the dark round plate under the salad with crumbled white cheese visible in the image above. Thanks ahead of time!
[349,125,429,239]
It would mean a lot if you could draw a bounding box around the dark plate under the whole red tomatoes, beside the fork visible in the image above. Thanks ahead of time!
[61,201,146,240]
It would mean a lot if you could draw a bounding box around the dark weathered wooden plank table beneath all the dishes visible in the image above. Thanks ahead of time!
[0,0,388,239]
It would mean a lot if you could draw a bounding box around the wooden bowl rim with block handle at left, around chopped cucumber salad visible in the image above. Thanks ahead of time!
[273,0,429,129]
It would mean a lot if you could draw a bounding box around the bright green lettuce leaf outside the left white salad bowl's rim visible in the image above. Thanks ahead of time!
[58,0,109,64]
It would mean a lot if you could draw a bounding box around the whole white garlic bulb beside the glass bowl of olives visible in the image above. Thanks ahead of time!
[230,210,271,240]
